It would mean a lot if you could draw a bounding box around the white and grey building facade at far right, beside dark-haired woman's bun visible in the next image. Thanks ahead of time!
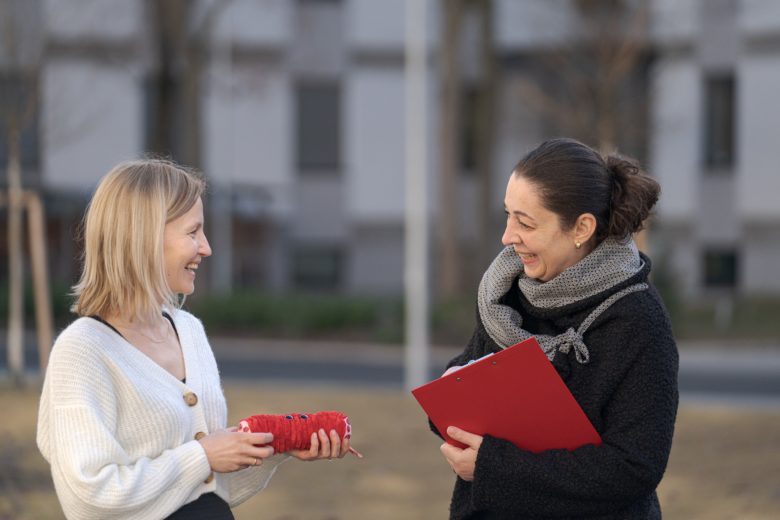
[650,0,780,297]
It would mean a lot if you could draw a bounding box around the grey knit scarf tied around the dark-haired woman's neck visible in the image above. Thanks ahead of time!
[477,238,648,364]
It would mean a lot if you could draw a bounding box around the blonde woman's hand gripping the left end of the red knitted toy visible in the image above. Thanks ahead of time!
[198,427,274,473]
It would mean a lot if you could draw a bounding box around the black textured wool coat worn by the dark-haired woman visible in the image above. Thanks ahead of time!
[448,260,678,520]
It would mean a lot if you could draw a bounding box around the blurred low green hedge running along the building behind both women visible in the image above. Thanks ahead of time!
[0,276,780,345]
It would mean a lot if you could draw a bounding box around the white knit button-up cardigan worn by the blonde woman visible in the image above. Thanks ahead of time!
[37,310,287,520]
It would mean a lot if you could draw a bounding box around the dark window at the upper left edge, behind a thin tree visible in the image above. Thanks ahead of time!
[0,71,39,175]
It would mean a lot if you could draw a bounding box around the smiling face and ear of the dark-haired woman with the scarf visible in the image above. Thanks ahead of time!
[501,174,595,282]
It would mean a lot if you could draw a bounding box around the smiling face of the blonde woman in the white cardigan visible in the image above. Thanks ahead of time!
[163,198,211,294]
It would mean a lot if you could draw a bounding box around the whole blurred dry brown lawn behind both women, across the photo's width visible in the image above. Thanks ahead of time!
[0,385,780,520]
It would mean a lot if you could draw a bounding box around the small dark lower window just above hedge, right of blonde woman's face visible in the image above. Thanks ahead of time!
[292,246,343,290]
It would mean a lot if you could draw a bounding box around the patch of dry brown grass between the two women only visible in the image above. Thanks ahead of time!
[227,386,452,520]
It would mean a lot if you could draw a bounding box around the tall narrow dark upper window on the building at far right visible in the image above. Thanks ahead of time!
[704,73,736,170]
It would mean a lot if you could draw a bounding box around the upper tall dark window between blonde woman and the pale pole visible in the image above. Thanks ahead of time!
[296,82,341,173]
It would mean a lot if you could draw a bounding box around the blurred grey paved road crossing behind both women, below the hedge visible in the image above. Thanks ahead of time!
[0,337,780,409]
